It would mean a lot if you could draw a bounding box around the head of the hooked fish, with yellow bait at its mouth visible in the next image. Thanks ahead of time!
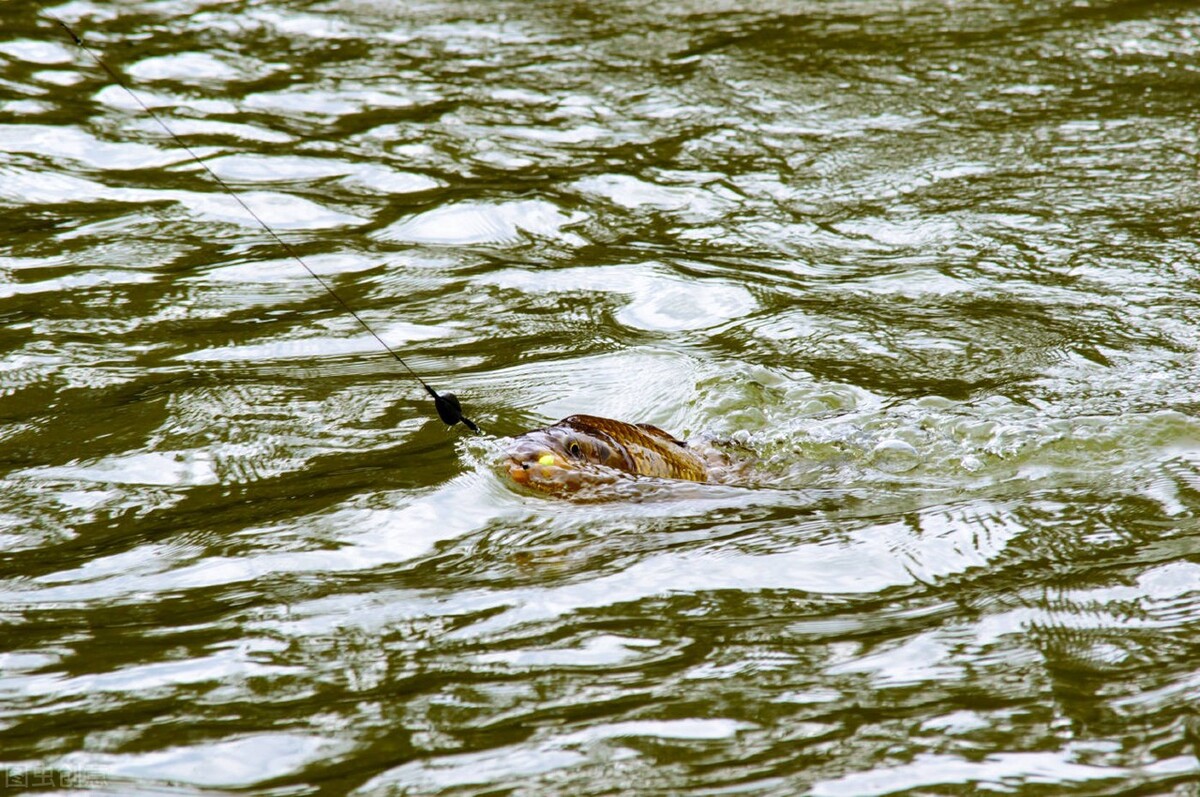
[504,423,634,492]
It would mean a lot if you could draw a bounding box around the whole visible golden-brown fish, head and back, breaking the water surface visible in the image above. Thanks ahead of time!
[504,415,709,492]
